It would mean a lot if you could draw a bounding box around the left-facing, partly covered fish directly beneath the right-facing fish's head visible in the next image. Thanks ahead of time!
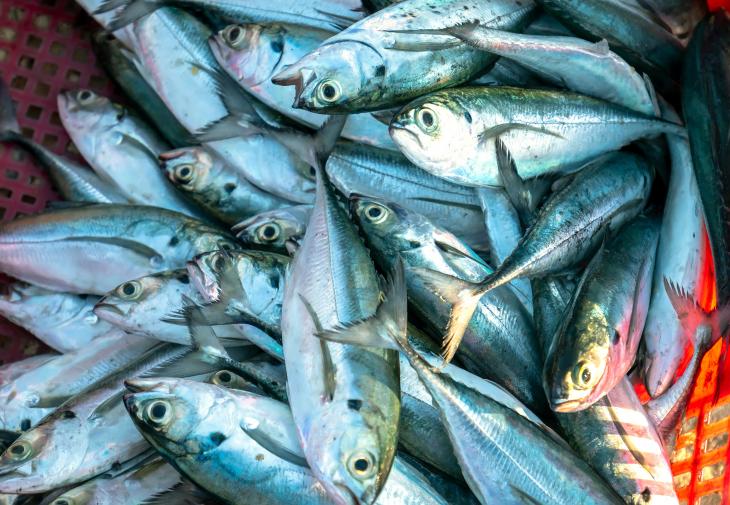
[91,268,244,345]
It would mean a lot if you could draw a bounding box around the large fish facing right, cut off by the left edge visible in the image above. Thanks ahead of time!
[0,204,236,295]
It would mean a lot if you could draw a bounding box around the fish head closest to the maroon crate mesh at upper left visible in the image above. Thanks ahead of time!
[56,89,120,134]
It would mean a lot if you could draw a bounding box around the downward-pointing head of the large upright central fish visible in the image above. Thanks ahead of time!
[307,400,395,505]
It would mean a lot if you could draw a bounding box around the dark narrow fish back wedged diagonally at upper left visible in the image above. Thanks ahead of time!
[91,30,192,147]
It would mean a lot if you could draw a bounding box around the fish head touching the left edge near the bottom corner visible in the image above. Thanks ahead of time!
[0,410,88,494]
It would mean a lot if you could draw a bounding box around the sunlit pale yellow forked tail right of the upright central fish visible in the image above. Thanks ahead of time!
[410,269,496,363]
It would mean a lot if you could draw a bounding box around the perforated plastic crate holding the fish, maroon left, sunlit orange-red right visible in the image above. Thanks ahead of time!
[0,0,730,505]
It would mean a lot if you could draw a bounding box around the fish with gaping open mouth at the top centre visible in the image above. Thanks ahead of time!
[272,0,535,111]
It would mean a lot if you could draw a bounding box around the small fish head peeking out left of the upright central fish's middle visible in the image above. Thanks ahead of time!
[236,211,306,249]
